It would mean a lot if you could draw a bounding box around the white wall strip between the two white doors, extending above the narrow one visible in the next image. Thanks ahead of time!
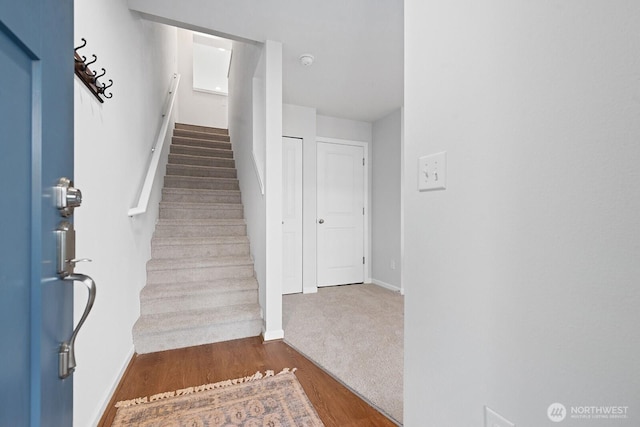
[282,104,318,293]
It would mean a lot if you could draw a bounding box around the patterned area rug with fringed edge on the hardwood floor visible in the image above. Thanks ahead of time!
[112,369,324,427]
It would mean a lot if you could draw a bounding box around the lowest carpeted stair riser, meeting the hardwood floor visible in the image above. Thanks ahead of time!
[134,319,262,354]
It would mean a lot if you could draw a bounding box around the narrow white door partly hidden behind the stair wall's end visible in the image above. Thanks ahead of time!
[282,137,302,294]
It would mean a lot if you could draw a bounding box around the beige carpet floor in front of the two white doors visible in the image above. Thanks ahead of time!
[283,284,404,424]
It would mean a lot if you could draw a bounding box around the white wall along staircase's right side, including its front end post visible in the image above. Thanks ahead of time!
[229,40,284,340]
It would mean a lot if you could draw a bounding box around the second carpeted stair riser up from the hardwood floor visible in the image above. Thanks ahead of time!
[140,289,258,315]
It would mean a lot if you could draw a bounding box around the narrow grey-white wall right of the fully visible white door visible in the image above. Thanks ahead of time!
[371,109,402,291]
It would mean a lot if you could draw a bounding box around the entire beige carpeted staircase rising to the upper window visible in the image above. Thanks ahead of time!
[133,123,262,354]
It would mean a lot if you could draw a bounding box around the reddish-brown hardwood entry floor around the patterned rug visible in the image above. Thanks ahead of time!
[98,337,395,427]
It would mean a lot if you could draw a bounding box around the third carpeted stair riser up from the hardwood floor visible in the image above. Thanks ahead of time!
[147,265,253,285]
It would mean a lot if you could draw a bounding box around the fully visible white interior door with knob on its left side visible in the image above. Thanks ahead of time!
[316,142,365,286]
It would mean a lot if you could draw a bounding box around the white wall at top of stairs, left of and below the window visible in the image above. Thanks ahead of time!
[177,28,228,129]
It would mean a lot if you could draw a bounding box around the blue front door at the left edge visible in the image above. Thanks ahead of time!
[0,0,74,427]
